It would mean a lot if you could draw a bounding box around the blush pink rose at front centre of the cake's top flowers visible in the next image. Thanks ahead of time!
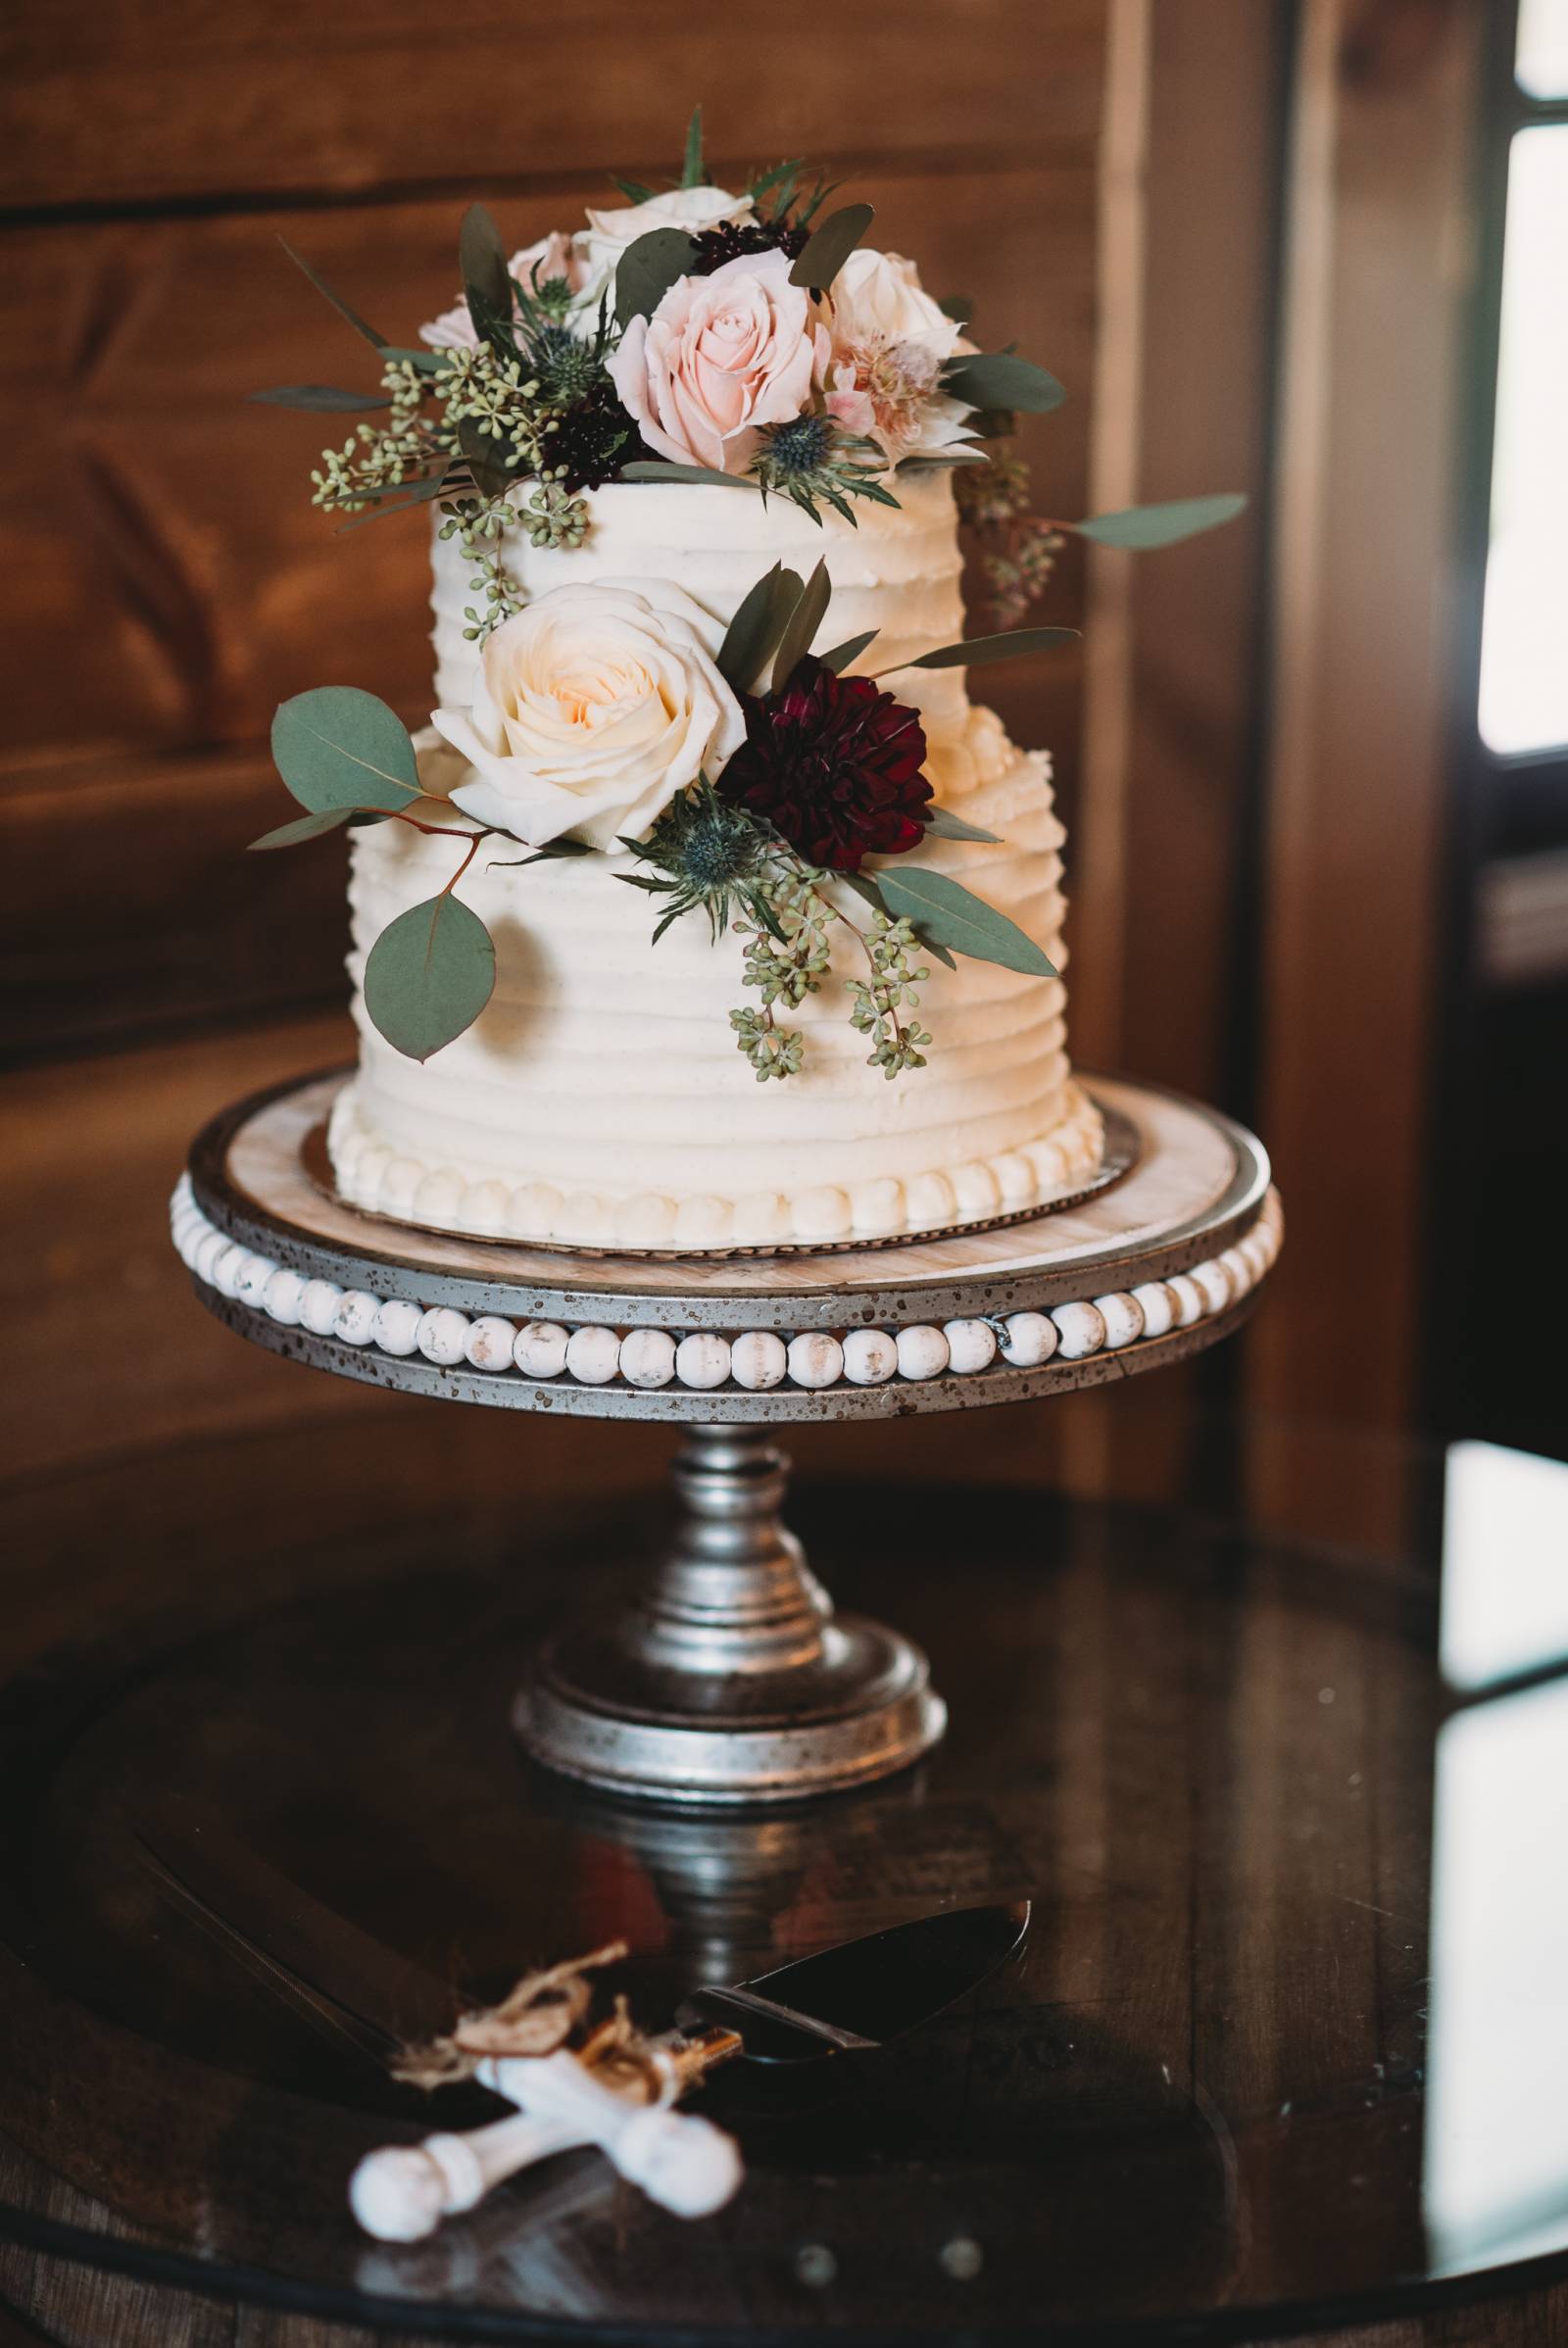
[611,254,829,472]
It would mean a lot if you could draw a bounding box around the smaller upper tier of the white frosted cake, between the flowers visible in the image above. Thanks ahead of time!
[429,469,967,740]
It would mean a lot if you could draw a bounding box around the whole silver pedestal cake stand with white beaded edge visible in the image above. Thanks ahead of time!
[173,1071,1282,1803]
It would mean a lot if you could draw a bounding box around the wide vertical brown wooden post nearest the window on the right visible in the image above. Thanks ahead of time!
[1253,0,1481,1465]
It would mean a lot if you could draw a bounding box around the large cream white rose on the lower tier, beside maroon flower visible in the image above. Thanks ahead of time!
[432,580,747,848]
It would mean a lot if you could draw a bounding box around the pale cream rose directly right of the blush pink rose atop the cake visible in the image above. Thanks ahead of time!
[824,244,972,465]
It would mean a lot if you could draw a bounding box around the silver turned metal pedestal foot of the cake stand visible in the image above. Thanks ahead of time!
[514,1423,946,1803]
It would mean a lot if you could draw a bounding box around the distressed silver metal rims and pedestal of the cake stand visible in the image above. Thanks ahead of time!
[176,1080,1272,1806]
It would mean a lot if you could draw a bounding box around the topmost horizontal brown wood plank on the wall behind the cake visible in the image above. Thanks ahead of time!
[0,0,1103,207]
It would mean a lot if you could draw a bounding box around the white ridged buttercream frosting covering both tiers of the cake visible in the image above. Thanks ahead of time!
[331,474,1101,1249]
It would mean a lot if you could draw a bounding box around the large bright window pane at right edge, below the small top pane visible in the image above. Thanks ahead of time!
[1479,125,1568,754]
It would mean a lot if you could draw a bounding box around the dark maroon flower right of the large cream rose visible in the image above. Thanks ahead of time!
[718,653,932,873]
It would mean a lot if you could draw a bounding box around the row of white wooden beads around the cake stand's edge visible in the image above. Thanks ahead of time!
[169,1174,1284,1394]
